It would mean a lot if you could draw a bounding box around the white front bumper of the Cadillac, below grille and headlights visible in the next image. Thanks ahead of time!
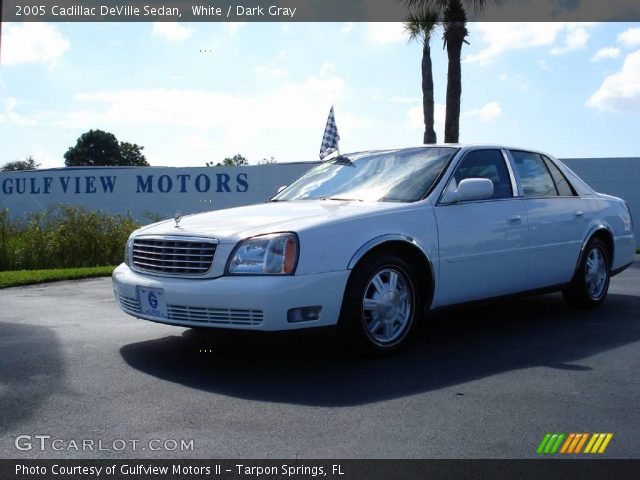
[112,263,350,331]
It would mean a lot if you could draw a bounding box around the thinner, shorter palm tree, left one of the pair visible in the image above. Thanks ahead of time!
[404,8,439,144]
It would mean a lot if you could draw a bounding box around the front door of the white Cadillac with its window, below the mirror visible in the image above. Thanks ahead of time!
[434,149,528,306]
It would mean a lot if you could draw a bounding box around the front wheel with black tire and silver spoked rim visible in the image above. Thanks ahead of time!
[338,253,423,355]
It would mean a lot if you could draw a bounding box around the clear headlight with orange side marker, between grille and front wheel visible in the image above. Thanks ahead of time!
[227,233,298,275]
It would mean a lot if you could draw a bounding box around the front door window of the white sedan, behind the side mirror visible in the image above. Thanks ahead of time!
[453,150,513,200]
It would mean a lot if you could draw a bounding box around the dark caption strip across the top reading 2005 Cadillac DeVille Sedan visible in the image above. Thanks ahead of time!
[2,0,640,22]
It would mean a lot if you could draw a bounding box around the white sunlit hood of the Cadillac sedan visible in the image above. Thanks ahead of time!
[136,200,406,243]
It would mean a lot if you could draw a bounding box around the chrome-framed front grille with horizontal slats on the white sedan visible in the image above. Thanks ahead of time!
[133,237,217,276]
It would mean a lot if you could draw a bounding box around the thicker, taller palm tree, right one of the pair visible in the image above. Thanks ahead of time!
[405,0,502,143]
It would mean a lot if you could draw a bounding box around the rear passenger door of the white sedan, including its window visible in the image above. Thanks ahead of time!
[509,150,590,289]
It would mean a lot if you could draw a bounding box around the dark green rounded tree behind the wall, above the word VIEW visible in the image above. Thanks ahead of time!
[64,130,149,167]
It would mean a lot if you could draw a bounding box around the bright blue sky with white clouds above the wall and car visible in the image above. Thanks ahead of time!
[0,22,640,168]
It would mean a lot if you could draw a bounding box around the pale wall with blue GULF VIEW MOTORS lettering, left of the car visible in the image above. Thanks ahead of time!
[0,162,314,220]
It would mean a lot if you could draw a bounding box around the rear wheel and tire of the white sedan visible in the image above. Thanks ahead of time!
[562,238,611,308]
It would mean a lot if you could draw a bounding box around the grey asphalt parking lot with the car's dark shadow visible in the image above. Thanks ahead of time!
[0,262,640,458]
